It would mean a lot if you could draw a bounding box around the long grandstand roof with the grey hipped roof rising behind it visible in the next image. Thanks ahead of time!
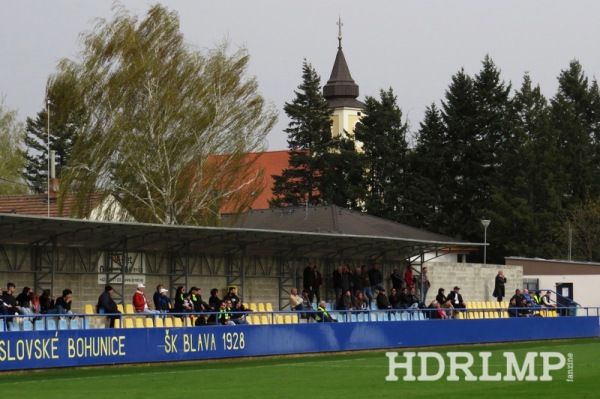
[0,207,482,259]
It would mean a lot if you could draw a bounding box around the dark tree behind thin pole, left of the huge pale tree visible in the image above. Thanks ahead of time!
[23,76,86,192]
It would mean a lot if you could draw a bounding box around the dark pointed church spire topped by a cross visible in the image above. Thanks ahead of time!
[323,17,364,108]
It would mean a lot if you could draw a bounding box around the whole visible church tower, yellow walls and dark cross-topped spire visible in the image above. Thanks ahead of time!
[323,18,365,141]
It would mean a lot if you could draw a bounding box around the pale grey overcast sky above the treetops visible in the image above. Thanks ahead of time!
[0,0,600,150]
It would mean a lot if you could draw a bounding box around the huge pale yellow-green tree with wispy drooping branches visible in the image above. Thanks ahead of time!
[51,5,276,225]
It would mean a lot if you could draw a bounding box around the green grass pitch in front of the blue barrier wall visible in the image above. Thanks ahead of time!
[0,339,600,399]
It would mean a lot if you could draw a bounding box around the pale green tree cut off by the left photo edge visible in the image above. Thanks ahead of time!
[0,99,27,195]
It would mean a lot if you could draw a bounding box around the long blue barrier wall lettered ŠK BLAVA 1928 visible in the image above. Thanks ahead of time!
[0,316,600,370]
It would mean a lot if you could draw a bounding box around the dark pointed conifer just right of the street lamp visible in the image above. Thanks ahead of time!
[491,75,562,257]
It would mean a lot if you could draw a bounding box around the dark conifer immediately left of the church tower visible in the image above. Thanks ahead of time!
[270,60,337,206]
